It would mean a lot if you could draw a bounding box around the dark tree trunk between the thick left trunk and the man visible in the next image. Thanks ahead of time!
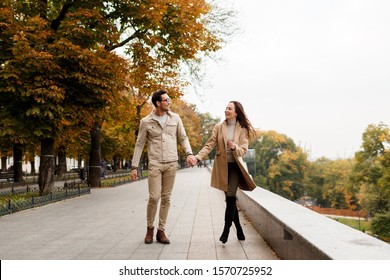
[88,123,102,188]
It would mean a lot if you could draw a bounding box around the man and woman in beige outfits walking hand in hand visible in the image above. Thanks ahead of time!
[130,90,256,244]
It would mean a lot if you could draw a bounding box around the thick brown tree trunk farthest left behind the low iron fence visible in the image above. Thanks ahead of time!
[38,138,54,195]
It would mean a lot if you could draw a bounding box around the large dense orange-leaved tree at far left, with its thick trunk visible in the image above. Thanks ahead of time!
[0,1,127,193]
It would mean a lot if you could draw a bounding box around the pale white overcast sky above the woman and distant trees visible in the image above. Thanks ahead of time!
[185,0,390,159]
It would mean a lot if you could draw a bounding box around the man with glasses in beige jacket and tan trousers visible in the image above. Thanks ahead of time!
[130,90,197,244]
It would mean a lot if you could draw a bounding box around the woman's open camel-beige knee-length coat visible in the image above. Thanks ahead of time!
[196,120,256,192]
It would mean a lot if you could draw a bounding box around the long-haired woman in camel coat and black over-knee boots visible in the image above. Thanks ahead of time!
[195,101,256,244]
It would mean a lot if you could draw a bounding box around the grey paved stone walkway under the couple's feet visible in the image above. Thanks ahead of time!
[0,168,277,260]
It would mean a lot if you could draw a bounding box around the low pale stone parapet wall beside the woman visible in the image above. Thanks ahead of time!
[238,187,390,260]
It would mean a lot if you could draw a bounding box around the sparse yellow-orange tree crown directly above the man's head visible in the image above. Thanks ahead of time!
[120,0,234,142]
